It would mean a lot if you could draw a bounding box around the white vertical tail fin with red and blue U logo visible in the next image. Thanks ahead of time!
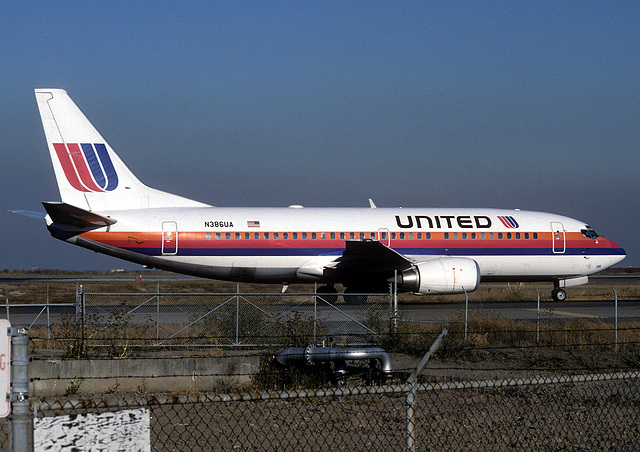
[35,89,206,211]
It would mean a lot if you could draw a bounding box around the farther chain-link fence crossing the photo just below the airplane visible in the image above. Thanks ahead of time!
[0,280,640,357]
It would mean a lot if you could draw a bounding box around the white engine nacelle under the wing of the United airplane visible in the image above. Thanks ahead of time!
[398,257,480,294]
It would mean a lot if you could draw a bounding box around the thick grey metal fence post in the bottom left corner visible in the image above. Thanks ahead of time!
[9,327,32,452]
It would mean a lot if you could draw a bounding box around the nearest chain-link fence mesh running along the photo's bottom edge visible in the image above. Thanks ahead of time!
[27,372,640,451]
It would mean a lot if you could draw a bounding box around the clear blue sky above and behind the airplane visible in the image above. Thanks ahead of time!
[0,1,640,270]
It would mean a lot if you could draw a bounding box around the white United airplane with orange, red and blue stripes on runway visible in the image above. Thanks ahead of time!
[35,89,626,304]
